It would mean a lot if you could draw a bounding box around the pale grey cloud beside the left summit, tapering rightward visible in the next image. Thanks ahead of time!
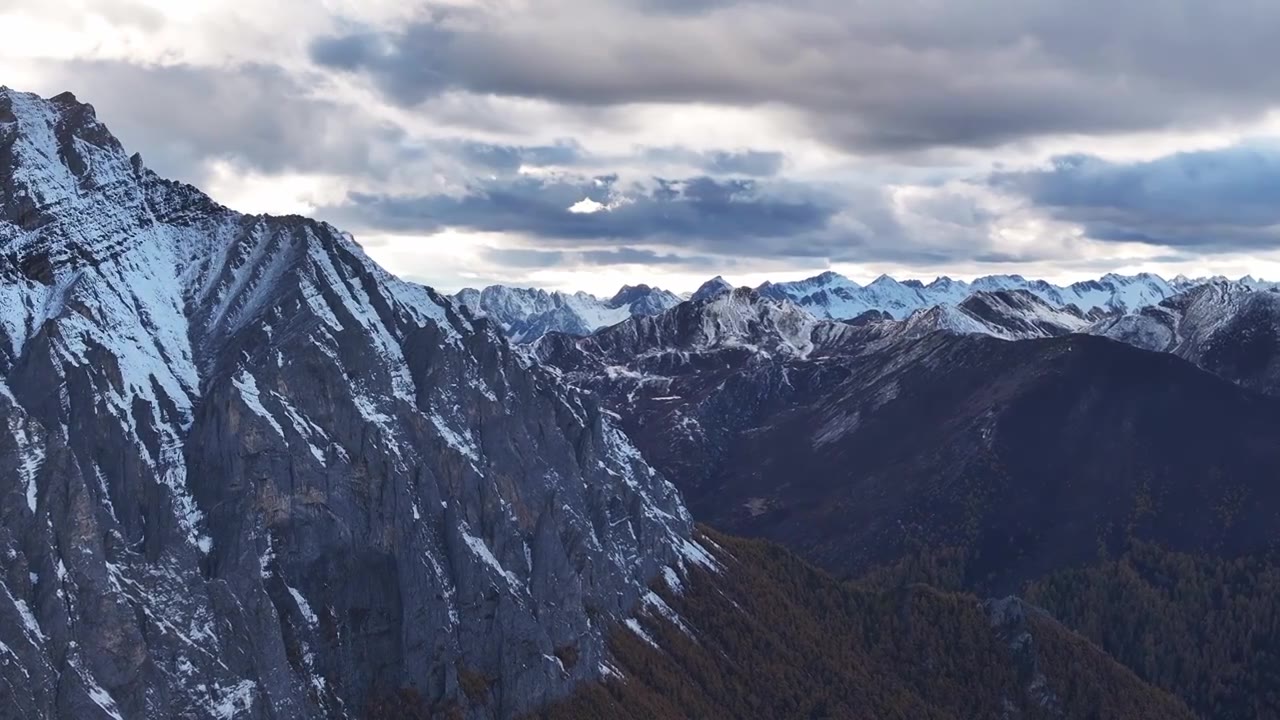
[37,61,782,189]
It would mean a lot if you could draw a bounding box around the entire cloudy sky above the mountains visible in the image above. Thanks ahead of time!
[0,0,1280,292]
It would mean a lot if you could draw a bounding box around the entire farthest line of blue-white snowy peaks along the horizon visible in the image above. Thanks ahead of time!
[454,272,1276,342]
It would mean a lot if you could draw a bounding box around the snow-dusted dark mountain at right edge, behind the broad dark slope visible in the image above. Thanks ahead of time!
[1088,278,1280,395]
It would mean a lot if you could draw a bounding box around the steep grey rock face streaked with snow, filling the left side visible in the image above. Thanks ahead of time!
[0,90,696,719]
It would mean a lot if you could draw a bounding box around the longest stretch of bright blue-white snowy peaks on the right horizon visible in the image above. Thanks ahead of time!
[759,272,1176,319]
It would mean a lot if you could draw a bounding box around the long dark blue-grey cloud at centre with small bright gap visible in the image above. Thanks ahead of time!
[320,170,1029,268]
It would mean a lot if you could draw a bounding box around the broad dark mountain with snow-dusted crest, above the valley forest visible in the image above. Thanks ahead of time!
[532,274,1280,592]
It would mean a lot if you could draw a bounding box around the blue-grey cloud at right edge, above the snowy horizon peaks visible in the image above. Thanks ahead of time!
[989,145,1280,252]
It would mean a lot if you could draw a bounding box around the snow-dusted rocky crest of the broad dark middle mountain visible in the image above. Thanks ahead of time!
[530,287,1092,425]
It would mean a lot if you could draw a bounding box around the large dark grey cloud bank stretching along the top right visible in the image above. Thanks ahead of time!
[311,0,1280,151]
